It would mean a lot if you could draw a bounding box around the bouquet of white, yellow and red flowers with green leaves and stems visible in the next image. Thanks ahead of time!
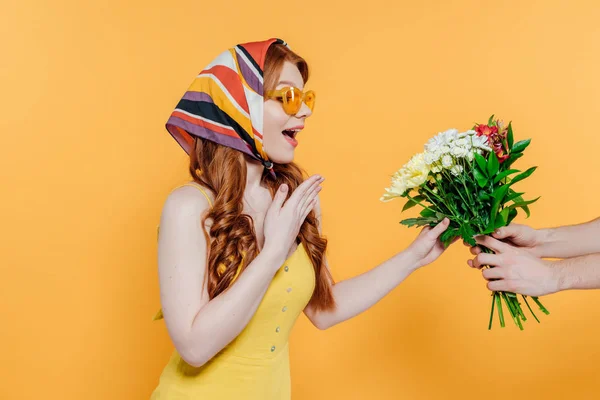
[381,115,549,330]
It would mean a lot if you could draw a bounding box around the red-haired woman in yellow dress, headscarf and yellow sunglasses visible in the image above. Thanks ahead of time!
[152,39,448,400]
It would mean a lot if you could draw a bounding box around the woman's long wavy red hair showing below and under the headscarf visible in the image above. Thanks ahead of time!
[189,44,335,310]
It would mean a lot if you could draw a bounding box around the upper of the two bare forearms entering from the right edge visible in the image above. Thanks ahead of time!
[537,218,600,258]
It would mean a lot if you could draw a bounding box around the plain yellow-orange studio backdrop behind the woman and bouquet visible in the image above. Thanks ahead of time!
[0,0,600,400]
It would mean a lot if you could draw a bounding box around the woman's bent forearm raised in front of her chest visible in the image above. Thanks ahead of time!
[186,251,284,366]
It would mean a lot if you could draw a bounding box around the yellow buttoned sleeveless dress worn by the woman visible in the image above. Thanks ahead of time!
[150,183,315,400]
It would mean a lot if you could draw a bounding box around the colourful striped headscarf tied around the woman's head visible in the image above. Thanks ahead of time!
[166,38,289,175]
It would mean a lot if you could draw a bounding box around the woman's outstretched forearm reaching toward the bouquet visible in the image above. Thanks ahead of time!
[309,251,418,329]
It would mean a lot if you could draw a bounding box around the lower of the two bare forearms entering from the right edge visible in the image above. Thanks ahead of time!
[555,253,600,290]
